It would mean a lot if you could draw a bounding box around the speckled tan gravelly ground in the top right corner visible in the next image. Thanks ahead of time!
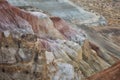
[71,0,120,27]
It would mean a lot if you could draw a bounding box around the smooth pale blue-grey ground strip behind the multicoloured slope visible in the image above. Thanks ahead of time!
[7,0,107,26]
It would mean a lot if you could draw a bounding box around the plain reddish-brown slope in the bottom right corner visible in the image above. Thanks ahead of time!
[87,62,120,80]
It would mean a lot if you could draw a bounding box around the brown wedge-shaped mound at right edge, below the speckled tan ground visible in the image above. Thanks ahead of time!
[94,26,120,46]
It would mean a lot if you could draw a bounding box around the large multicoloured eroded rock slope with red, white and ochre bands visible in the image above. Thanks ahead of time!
[0,0,118,80]
